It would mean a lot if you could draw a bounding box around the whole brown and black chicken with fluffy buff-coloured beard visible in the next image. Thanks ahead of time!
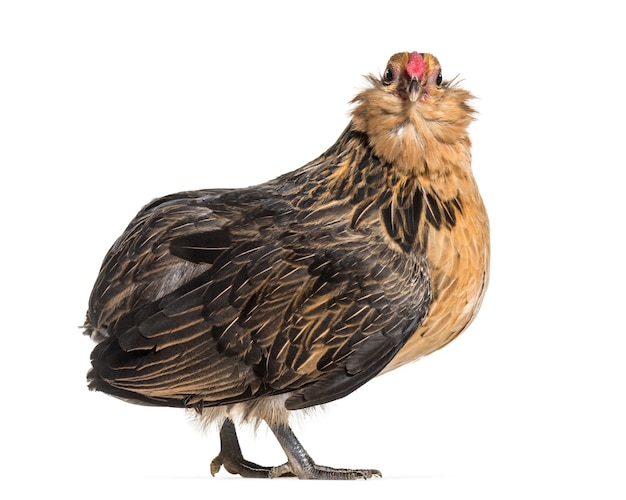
[85,52,489,479]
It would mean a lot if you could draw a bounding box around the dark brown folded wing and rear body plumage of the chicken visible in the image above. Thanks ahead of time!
[89,187,430,409]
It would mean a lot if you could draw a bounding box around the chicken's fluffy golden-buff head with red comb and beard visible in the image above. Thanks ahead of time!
[352,52,474,184]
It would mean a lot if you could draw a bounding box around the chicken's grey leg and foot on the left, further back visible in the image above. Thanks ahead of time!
[211,418,293,477]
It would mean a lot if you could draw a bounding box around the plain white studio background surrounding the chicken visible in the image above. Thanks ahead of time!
[0,0,626,499]
